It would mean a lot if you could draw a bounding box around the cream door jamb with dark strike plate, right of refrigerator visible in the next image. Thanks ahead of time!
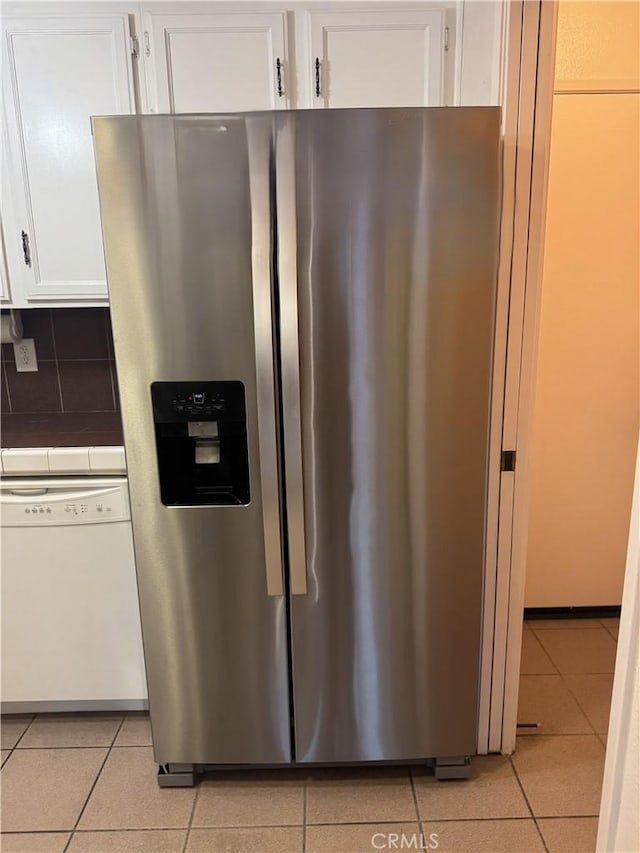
[478,0,557,754]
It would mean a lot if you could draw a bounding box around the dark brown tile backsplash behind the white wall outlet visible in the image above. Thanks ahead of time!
[2,308,119,414]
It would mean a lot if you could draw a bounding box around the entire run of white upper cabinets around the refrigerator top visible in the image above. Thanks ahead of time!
[0,0,472,307]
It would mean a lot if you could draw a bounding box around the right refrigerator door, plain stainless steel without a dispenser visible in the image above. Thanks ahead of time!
[276,108,499,762]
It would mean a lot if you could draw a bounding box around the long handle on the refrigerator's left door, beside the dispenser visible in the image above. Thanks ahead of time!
[247,118,284,595]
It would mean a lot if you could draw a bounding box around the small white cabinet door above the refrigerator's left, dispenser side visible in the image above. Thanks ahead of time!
[143,4,290,113]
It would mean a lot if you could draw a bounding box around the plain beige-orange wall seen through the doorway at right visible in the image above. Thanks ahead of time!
[525,0,640,607]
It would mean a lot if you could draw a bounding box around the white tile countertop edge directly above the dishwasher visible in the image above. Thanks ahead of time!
[0,445,127,477]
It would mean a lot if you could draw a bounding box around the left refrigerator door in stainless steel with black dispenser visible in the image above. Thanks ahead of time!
[93,116,291,764]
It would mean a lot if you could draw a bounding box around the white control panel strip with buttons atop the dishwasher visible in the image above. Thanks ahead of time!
[0,480,131,527]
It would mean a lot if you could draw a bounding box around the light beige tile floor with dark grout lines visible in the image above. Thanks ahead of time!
[2,619,617,853]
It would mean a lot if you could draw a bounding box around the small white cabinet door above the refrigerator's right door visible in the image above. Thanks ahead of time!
[309,9,444,107]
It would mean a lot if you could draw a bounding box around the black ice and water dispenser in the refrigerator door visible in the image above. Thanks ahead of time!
[151,381,251,506]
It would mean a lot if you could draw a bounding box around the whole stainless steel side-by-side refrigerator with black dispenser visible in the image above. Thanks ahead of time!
[93,108,500,785]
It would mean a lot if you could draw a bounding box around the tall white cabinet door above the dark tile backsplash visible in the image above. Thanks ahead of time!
[2,15,135,301]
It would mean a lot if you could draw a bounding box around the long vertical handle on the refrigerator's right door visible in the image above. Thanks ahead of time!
[276,118,307,595]
